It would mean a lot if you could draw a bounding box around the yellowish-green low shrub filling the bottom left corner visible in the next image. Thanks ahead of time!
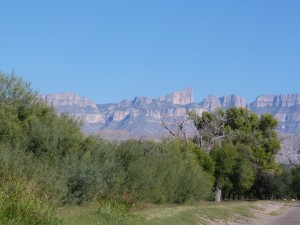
[0,174,63,225]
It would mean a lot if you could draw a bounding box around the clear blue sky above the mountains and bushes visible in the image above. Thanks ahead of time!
[0,0,300,103]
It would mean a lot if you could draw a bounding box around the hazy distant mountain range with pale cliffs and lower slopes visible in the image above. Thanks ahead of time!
[42,88,300,163]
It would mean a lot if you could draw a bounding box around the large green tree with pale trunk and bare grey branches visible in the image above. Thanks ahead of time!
[188,107,280,200]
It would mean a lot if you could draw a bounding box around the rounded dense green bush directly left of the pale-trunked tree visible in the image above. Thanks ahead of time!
[109,141,213,203]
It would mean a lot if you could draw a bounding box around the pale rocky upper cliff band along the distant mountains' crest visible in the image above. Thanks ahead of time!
[41,88,300,133]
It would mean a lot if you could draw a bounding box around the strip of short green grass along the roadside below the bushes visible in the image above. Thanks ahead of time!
[57,202,264,225]
